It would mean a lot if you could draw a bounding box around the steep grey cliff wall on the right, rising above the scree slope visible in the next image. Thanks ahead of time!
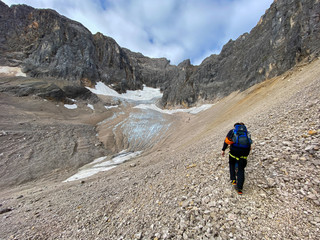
[163,0,320,105]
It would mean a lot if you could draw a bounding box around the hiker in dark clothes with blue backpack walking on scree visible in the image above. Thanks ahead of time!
[221,123,252,194]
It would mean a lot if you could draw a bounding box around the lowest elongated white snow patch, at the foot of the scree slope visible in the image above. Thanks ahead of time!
[63,150,141,182]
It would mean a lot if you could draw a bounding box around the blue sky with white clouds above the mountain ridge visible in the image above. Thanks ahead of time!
[2,0,273,65]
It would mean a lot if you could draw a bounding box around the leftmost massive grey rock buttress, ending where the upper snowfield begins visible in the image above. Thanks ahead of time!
[1,4,98,80]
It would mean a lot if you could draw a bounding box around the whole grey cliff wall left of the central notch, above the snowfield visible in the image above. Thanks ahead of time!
[0,2,177,92]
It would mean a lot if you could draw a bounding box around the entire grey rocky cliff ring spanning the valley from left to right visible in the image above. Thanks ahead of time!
[0,0,320,106]
